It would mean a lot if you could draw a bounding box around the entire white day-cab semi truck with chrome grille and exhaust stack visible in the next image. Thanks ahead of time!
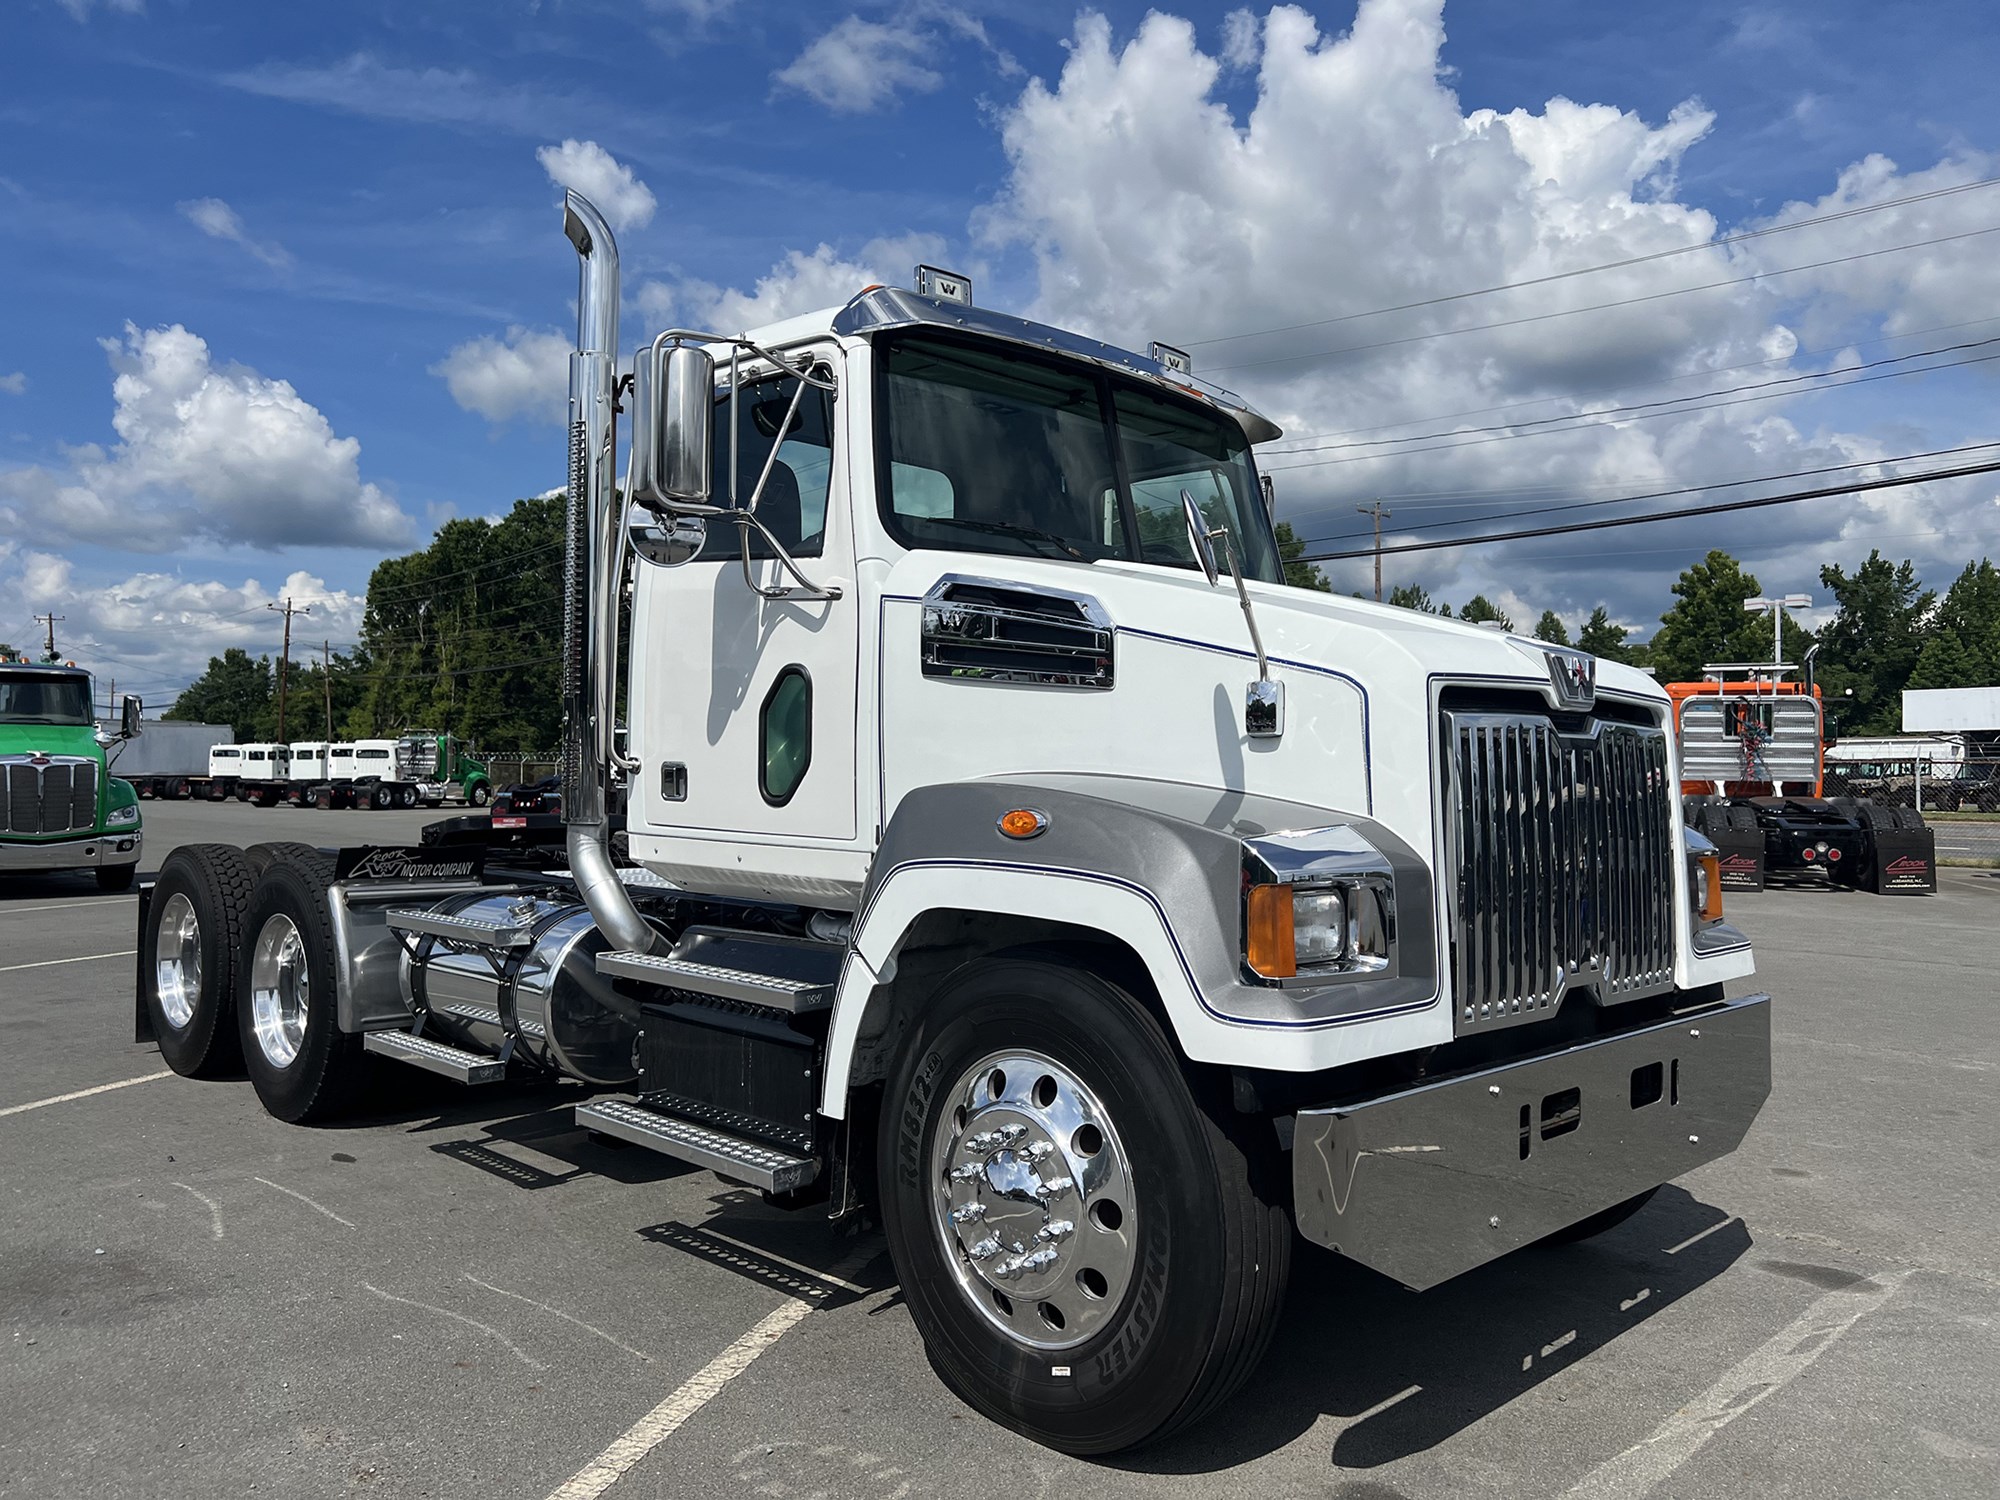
[138,194,1770,1454]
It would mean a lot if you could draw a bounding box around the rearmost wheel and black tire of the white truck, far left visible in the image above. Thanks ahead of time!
[140,844,256,1078]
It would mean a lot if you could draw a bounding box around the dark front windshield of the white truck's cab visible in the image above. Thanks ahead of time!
[878,336,1282,582]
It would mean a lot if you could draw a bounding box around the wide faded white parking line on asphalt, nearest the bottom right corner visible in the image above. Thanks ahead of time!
[1568,1270,1912,1500]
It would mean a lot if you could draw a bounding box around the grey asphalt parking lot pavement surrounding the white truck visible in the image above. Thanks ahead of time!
[0,804,2000,1500]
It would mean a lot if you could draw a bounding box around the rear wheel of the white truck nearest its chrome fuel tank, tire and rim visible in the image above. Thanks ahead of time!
[236,860,364,1124]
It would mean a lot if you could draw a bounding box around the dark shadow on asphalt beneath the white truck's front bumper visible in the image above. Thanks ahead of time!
[1112,1186,1750,1500]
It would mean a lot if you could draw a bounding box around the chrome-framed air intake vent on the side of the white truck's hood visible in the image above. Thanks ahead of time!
[922,576,1114,688]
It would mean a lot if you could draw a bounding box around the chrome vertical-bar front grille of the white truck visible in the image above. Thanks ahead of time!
[1444,712,1674,1032]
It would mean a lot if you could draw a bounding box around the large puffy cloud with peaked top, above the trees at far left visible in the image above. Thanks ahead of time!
[0,324,414,552]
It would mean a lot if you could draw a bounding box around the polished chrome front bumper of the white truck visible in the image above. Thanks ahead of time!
[1292,994,1770,1292]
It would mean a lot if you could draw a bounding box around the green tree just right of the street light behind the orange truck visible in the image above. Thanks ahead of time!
[1818,552,1936,734]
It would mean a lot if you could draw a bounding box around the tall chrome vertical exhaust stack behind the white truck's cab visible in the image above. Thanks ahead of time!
[562,192,658,952]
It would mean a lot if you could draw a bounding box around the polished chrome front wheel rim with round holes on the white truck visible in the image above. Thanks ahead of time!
[930,1050,1138,1350]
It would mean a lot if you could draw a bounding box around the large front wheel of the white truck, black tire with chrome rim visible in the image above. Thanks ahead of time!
[878,956,1292,1454]
